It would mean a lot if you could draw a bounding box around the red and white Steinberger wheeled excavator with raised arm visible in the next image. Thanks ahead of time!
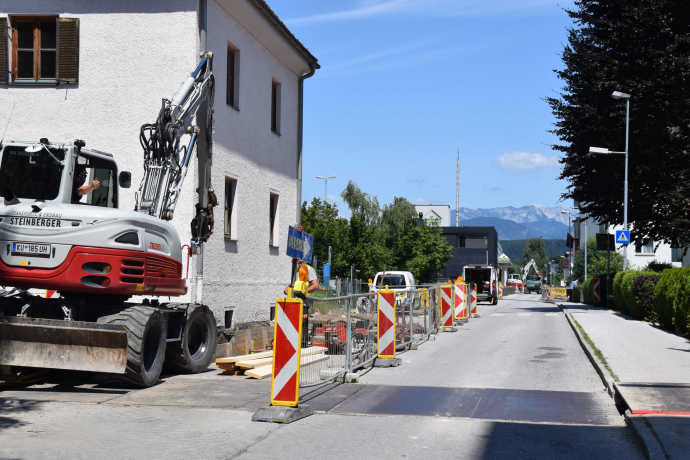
[0,52,217,387]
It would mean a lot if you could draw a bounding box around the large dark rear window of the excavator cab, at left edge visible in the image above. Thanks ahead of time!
[0,145,65,200]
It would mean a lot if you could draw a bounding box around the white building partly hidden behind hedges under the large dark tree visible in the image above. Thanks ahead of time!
[573,216,685,275]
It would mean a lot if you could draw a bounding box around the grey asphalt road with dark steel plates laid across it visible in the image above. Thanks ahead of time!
[0,295,644,459]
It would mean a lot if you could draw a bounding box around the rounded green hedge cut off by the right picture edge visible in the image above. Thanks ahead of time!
[654,267,690,335]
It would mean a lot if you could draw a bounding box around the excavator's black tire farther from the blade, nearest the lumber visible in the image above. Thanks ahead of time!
[165,304,217,374]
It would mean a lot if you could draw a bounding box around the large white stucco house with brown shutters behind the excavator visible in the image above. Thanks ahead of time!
[0,0,319,323]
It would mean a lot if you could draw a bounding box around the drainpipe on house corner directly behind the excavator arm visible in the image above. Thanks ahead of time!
[196,0,210,303]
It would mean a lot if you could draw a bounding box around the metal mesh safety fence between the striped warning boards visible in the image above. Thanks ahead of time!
[299,285,440,388]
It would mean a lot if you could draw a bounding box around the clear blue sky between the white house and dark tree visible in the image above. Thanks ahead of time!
[269,0,572,216]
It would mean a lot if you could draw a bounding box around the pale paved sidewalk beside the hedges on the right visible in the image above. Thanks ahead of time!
[559,302,690,459]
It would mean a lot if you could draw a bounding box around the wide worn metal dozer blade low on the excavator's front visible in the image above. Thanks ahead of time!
[0,316,127,374]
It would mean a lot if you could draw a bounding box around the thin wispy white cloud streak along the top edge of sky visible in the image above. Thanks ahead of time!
[285,0,557,27]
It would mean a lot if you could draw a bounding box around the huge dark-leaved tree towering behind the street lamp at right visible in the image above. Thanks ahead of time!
[546,0,690,247]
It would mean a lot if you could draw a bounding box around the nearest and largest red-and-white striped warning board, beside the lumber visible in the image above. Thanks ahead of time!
[271,299,303,407]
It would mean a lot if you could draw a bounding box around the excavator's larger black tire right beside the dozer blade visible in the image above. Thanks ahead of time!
[96,306,167,387]
